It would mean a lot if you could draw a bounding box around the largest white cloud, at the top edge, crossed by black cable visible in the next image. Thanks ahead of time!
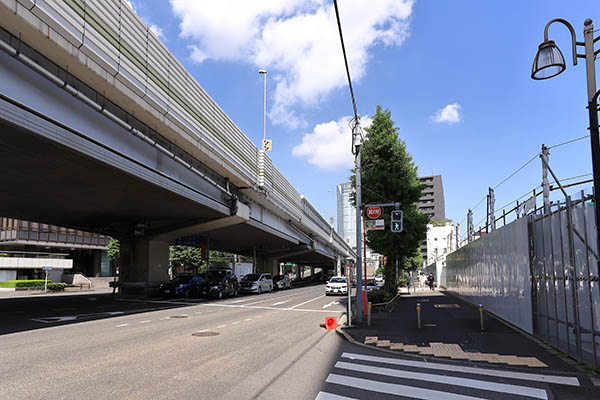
[170,0,414,127]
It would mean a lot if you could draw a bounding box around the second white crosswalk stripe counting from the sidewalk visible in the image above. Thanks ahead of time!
[335,361,548,399]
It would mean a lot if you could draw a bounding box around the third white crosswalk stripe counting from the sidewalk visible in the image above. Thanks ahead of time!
[325,374,485,400]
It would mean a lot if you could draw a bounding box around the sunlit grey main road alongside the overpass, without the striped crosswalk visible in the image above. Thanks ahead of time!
[0,285,345,399]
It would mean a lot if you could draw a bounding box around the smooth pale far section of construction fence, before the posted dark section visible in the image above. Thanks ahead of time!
[446,218,533,333]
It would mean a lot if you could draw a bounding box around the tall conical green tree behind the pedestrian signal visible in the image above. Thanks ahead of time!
[351,106,428,291]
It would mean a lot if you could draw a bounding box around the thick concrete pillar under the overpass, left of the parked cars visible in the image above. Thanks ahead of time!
[119,238,169,282]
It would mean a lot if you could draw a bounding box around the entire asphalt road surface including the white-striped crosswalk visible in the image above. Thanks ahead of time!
[0,285,598,400]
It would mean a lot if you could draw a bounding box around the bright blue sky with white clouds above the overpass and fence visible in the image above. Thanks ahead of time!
[132,0,600,238]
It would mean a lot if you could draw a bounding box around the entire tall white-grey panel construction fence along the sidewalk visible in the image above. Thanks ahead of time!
[442,191,600,367]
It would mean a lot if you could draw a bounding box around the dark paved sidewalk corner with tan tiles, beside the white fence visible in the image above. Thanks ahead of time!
[344,289,581,373]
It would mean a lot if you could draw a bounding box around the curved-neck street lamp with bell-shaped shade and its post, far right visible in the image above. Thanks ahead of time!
[531,18,600,270]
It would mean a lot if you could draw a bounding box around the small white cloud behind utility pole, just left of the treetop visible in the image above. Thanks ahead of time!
[292,117,371,170]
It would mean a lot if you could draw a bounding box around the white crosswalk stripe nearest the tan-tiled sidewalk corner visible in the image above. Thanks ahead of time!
[342,352,580,386]
